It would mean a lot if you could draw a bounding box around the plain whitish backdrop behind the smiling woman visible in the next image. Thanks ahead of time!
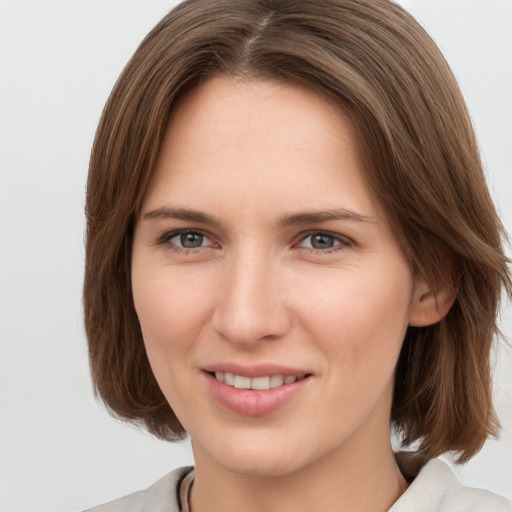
[0,0,512,512]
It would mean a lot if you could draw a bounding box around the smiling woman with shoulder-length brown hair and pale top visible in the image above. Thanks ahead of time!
[84,0,511,512]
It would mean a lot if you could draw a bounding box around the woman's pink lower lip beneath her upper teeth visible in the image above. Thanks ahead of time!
[204,372,311,416]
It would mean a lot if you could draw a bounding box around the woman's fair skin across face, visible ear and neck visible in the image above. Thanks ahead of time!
[132,78,448,512]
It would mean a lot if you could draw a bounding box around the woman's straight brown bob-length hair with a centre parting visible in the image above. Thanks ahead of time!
[84,0,511,462]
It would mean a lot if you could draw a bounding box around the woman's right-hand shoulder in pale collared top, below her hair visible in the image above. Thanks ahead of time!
[389,459,512,512]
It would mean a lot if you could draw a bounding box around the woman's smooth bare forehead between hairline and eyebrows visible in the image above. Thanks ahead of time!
[142,77,378,218]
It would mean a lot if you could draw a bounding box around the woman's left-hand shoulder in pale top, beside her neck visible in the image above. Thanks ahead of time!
[84,467,192,512]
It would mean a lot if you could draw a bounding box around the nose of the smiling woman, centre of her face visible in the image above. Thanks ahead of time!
[212,250,291,348]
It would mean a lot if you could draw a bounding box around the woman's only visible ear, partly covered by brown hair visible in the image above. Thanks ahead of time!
[409,277,458,327]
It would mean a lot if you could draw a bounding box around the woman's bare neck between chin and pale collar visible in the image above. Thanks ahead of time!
[190,440,407,512]
